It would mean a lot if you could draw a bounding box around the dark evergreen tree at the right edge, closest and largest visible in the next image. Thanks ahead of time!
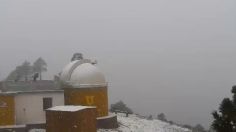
[212,86,236,132]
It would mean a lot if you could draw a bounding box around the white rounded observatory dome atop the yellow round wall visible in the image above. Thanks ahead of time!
[61,60,106,87]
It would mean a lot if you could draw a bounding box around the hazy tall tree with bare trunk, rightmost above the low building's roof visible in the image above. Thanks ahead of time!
[33,57,47,80]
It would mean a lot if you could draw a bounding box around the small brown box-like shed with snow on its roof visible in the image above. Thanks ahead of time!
[46,105,97,132]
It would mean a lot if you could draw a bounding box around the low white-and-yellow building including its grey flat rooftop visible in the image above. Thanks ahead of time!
[0,81,64,126]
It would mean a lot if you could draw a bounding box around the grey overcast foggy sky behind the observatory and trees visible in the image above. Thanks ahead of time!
[0,0,236,127]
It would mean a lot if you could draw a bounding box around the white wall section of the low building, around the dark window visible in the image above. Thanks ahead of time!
[15,92,64,124]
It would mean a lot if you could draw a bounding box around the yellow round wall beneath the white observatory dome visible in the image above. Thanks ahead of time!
[64,87,108,117]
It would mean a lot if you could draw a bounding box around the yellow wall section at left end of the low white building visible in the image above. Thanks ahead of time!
[0,95,15,126]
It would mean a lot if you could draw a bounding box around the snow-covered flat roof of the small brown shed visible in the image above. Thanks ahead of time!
[47,105,96,112]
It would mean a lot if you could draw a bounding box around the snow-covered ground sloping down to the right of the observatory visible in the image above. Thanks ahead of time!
[30,114,191,132]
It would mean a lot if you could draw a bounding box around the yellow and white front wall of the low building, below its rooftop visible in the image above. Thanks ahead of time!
[0,90,64,125]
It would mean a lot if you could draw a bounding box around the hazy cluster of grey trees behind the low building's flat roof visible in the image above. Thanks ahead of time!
[6,57,47,82]
